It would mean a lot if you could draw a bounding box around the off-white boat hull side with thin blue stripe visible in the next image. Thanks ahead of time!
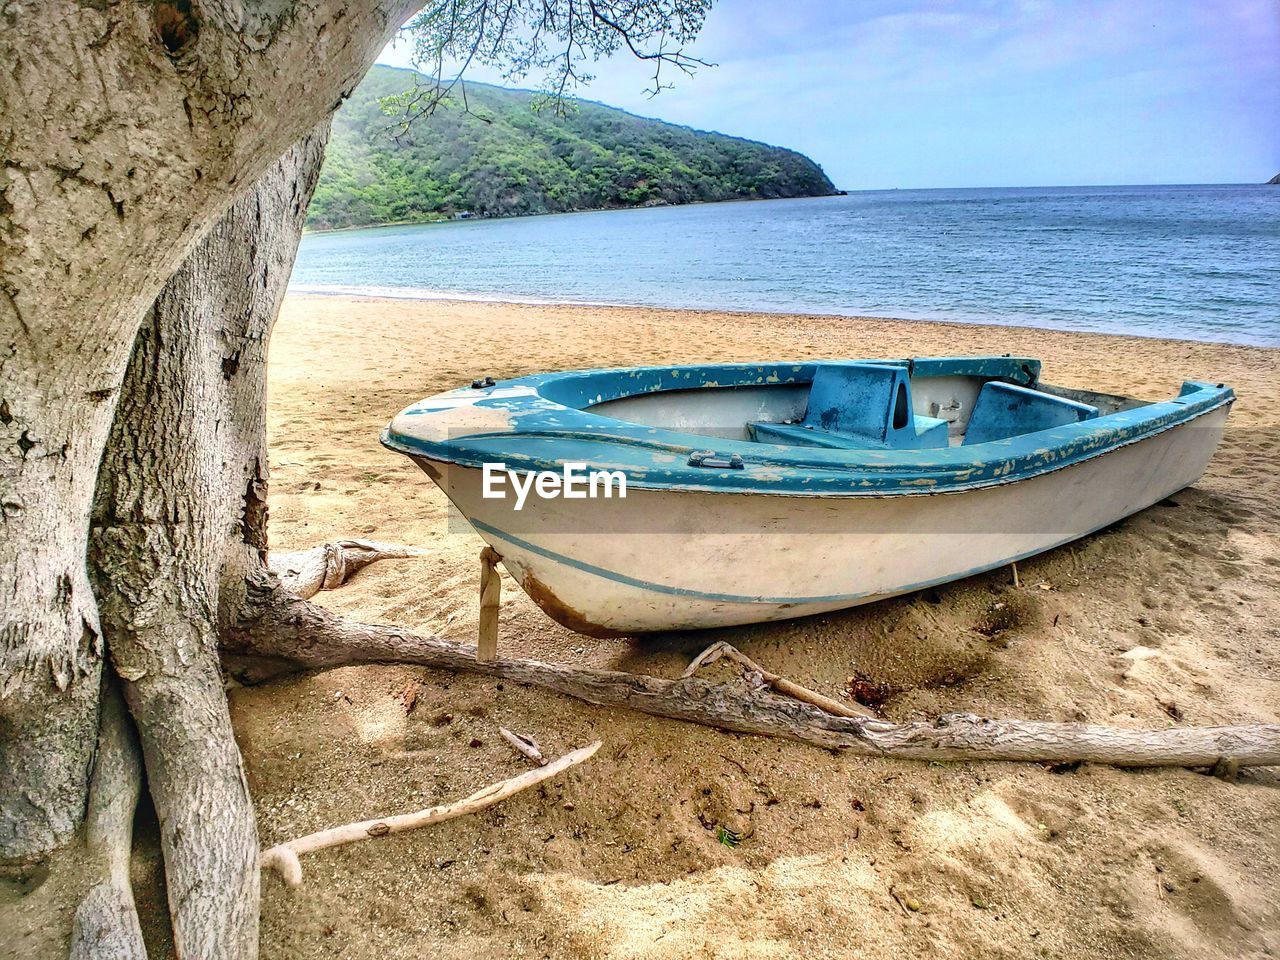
[415,406,1229,636]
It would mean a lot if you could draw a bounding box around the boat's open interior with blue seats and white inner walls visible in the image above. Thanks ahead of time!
[588,361,1146,449]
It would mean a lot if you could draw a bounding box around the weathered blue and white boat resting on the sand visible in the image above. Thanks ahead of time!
[381,356,1235,636]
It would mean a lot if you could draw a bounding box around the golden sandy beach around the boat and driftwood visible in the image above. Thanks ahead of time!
[235,296,1280,960]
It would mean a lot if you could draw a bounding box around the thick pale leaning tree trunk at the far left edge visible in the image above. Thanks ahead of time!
[0,0,419,859]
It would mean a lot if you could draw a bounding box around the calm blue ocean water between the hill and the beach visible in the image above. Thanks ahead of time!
[291,186,1280,346]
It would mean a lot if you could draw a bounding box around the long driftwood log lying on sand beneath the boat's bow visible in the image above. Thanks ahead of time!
[228,598,1280,767]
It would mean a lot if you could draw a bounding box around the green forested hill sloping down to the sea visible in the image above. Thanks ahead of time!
[307,67,835,229]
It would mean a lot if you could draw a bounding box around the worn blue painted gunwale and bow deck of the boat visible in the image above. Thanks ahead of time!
[381,356,1235,497]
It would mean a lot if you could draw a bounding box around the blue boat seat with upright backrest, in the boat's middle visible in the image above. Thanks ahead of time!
[746,364,947,449]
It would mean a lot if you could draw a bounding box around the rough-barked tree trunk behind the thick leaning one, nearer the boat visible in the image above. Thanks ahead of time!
[91,120,329,959]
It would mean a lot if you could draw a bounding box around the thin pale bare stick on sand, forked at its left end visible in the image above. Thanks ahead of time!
[260,740,600,887]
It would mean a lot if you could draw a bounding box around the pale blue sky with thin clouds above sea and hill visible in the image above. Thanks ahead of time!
[379,0,1280,189]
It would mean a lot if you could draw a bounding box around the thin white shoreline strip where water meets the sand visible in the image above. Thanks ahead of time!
[285,293,1280,352]
